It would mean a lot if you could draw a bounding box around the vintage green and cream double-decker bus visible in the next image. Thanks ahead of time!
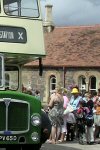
[0,0,49,150]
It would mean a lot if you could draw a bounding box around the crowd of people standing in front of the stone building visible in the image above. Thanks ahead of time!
[47,86,100,145]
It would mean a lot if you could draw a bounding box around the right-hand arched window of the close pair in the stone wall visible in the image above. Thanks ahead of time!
[89,76,96,91]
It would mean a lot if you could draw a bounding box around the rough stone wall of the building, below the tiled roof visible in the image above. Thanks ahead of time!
[22,68,100,103]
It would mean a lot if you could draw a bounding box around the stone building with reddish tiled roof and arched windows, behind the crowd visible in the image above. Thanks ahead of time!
[23,25,100,103]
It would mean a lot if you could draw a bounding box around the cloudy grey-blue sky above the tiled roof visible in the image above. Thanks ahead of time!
[41,0,100,26]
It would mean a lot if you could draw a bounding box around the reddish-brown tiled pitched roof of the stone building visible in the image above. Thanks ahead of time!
[28,25,100,67]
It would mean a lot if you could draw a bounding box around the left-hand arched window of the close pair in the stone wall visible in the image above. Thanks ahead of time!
[78,75,86,92]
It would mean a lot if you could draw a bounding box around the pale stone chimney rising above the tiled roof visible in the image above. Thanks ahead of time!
[43,4,54,32]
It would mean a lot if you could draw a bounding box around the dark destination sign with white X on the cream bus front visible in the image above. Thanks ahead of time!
[0,26,27,43]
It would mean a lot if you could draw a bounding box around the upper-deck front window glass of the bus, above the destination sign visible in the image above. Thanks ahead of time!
[4,0,39,17]
